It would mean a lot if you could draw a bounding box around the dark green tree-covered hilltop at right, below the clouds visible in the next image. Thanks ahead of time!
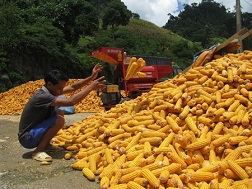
[164,1,236,48]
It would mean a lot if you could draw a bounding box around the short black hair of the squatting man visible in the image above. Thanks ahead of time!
[44,70,69,85]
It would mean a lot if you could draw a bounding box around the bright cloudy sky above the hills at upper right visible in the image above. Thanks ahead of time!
[121,0,252,27]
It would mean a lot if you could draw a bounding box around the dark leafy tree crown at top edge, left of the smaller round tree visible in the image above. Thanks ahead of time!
[41,0,99,45]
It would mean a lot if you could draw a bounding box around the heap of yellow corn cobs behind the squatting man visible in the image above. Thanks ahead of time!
[0,79,104,115]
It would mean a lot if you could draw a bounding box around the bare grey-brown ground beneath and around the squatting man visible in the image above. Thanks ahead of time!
[0,113,99,189]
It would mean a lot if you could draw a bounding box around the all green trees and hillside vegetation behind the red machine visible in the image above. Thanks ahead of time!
[0,0,252,92]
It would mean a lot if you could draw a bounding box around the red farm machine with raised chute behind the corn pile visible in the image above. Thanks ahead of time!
[90,47,177,109]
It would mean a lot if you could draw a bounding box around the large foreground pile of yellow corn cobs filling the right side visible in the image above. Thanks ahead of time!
[53,50,252,189]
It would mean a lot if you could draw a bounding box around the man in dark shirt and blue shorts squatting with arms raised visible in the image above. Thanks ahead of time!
[18,64,105,161]
